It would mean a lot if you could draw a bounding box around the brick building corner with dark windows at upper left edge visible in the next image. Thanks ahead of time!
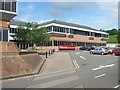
[0,0,17,42]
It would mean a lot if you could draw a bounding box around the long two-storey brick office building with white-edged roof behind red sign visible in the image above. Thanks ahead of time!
[39,20,109,46]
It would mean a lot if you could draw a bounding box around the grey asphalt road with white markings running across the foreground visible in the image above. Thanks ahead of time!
[2,51,120,88]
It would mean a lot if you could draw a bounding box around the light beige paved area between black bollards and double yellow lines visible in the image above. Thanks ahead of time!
[40,52,74,74]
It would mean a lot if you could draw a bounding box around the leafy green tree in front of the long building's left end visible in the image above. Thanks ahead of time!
[14,23,50,50]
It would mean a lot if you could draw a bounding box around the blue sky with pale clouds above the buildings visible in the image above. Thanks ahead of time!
[14,2,118,30]
